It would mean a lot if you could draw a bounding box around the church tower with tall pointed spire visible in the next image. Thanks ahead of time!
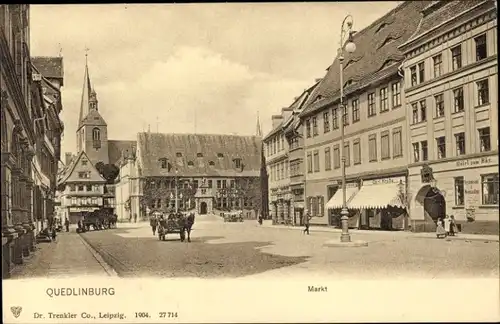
[76,54,109,165]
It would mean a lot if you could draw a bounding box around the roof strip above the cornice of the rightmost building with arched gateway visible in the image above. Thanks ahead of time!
[402,0,493,46]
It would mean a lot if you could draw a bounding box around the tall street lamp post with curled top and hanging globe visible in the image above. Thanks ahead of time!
[339,15,356,243]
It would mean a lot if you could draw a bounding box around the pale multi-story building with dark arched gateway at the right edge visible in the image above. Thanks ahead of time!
[400,0,499,233]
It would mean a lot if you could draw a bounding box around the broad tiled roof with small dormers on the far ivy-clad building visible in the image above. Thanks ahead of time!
[137,133,262,177]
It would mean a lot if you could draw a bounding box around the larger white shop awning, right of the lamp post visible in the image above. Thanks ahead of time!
[349,183,405,209]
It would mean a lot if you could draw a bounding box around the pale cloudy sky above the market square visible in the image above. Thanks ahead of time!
[30,2,398,152]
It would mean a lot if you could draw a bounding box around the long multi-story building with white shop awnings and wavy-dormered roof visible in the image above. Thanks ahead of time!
[300,1,429,229]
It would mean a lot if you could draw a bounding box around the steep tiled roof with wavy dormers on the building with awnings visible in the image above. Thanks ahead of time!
[301,1,431,115]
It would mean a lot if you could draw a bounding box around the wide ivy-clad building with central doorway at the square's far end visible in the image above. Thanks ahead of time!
[116,132,262,220]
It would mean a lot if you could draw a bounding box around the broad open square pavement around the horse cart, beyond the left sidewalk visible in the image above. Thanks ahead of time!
[72,216,499,279]
